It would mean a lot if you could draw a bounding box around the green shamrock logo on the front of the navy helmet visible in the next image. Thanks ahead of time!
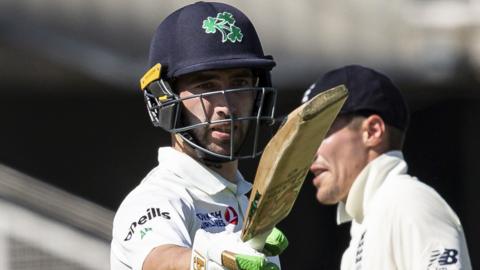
[202,11,243,43]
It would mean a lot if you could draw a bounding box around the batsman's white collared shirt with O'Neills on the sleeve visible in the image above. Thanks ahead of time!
[110,147,251,270]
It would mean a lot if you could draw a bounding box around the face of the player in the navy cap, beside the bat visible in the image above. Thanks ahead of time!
[310,116,368,204]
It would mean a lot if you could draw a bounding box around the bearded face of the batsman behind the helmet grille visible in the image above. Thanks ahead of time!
[176,68,256,155]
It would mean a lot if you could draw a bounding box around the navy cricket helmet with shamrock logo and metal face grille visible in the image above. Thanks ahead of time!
[141,2,276,161]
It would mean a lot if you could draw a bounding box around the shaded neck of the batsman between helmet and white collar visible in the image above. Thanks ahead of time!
[172,135,238,184]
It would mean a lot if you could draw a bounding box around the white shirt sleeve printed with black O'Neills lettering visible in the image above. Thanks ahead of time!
[111,184,192,270]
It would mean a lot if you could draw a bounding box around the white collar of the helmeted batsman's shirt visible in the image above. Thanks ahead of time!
[158,147,252,195]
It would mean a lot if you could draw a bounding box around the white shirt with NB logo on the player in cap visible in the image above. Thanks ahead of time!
[337,151,471,270]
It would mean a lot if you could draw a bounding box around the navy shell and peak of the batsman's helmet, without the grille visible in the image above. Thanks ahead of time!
[149,2,275,86]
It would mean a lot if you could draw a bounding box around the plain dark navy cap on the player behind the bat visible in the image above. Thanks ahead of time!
[302,65,409,131]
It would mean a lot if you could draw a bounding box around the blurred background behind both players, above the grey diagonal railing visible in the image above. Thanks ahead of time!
[0,0,480,269]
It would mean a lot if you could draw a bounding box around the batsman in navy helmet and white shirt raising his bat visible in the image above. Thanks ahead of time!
[111,2,283,270]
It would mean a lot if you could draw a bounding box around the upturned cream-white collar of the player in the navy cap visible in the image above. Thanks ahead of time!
[337,151,407,224]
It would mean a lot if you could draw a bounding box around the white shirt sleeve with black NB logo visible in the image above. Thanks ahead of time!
[393,180,471,270]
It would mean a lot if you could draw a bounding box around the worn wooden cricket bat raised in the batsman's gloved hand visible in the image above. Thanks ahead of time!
[222,85,348,270]
